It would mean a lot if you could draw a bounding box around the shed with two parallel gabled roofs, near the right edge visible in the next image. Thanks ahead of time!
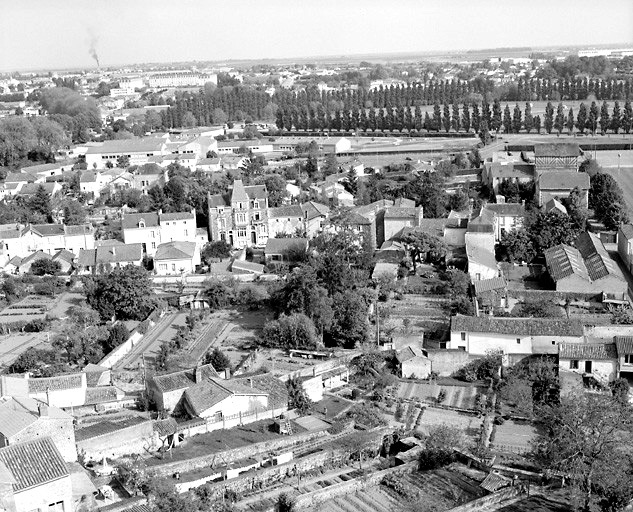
[545,232,628,300]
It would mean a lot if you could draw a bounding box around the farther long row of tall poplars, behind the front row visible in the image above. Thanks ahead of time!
[161,77,633,128]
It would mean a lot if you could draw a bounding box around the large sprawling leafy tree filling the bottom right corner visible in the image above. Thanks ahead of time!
[533,393,633,512]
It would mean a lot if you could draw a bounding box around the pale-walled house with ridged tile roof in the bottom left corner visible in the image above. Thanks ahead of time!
[0,437,73,512]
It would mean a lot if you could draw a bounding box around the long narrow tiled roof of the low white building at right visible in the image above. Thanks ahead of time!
[451,315,584,336]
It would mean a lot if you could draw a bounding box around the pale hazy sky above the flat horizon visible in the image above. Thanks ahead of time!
[0,0,633,70]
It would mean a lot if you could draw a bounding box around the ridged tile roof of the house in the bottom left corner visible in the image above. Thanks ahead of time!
[0,437,69,492]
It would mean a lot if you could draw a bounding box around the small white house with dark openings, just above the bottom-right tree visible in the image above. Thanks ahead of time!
[558,343,618,384]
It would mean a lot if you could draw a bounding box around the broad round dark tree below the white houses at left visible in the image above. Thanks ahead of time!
[84,265,156,321]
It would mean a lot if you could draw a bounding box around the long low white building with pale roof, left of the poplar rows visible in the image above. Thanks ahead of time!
[86,137,166,169]
